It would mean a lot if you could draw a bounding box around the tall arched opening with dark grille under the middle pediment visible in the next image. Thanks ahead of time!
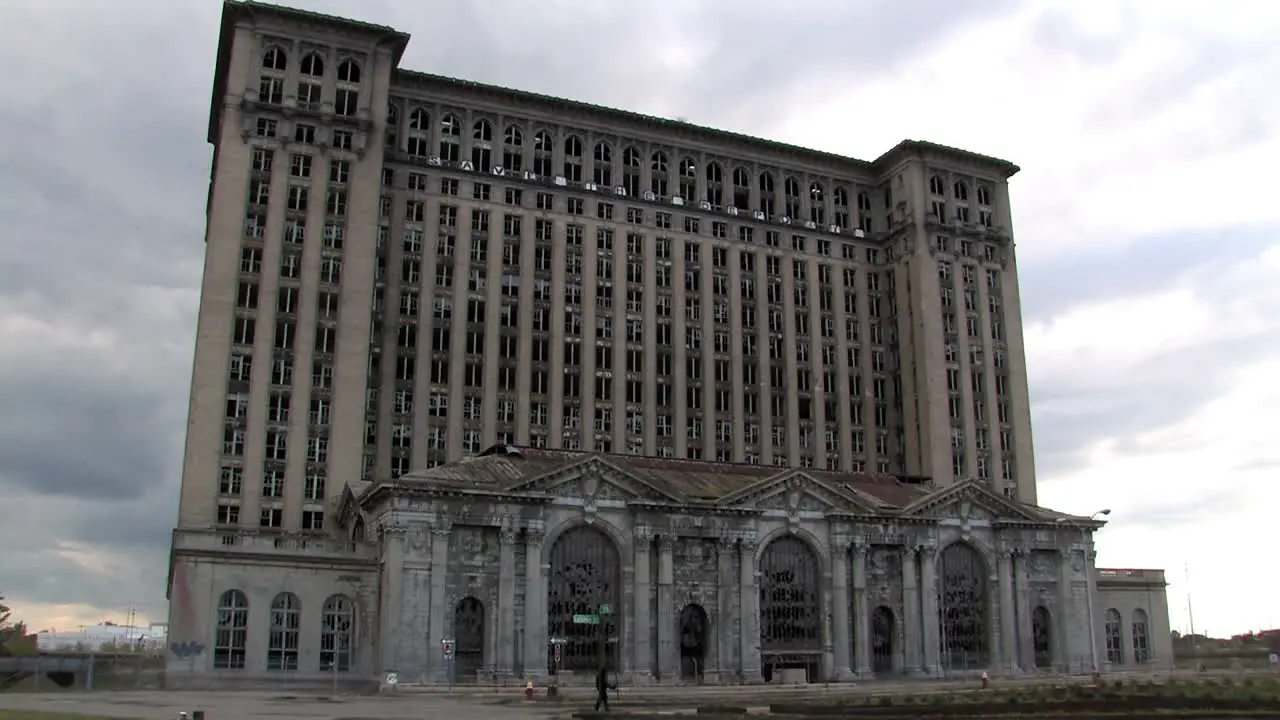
[760,536,822,683]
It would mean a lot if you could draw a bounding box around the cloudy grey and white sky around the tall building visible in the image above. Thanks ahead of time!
[0,0,1280,634]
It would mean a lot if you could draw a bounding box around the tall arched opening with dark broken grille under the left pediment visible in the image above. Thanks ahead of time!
[547,525,622,673]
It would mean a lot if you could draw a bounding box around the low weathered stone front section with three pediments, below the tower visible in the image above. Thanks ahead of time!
[170,446,1171,683]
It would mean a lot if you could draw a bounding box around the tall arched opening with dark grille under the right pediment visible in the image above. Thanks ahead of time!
[938,542,991,670]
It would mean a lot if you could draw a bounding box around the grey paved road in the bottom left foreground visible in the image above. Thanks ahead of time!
[0,692,570,720]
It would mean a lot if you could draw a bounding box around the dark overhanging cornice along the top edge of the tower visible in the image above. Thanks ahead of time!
[209,0,1020,179]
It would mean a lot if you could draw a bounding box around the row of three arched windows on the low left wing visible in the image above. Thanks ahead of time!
[214,589,356,673]
